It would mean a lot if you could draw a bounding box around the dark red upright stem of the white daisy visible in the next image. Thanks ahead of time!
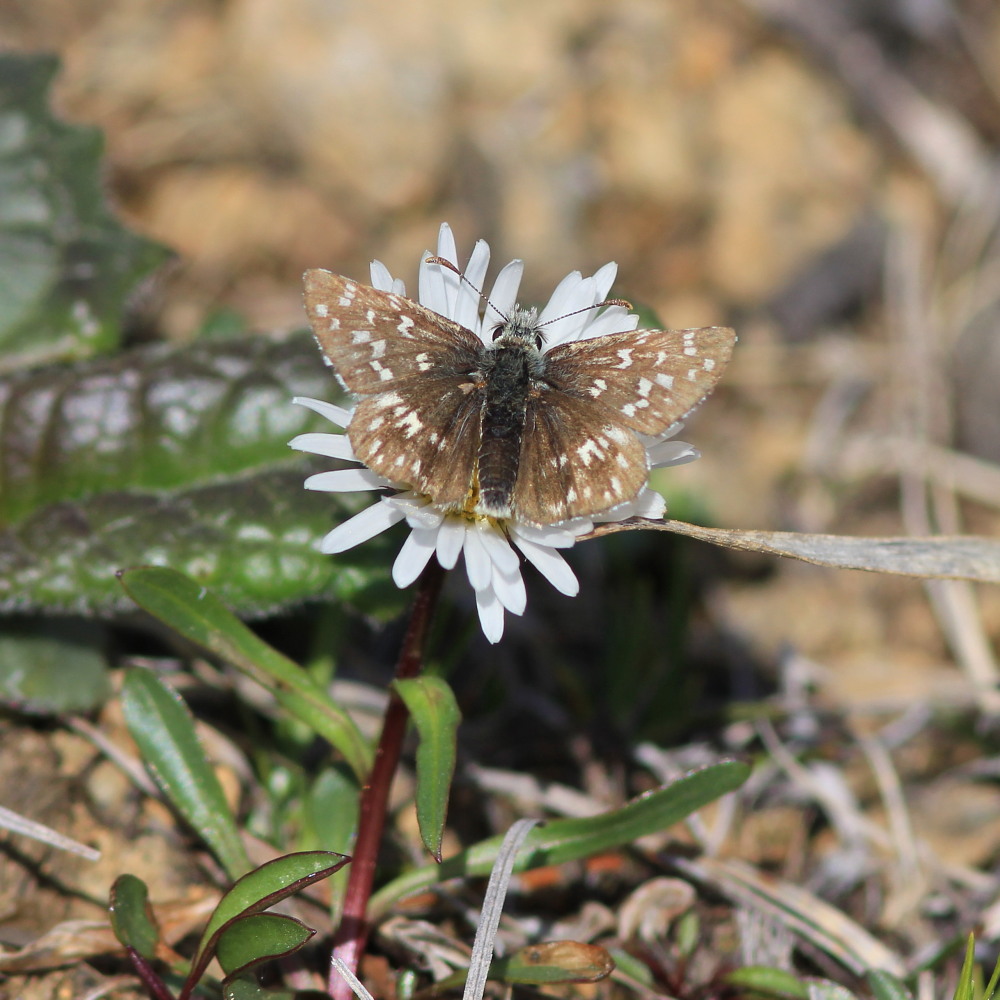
[328,559,444,1000]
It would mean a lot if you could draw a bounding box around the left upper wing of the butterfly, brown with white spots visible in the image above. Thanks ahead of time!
[305,270,481,396]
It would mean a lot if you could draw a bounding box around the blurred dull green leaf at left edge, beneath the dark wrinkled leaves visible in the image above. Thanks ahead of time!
[0,619,111,713]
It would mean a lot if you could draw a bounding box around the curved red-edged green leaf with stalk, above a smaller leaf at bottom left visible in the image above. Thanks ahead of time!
[181,851,350,1000]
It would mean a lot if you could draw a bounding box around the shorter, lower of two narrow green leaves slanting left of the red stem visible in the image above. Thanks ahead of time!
[122,668,250,878]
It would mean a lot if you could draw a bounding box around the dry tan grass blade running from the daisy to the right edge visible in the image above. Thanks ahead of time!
[580,518,1000,583]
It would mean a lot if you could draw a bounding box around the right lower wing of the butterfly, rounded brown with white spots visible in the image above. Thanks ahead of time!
[513,389,649,524]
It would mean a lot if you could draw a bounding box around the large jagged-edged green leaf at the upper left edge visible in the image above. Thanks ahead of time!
[0,52,167,370]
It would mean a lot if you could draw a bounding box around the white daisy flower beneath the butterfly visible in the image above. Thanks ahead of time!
[290,224,698,642]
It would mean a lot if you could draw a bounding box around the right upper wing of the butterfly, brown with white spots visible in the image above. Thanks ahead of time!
[546,326,736,435]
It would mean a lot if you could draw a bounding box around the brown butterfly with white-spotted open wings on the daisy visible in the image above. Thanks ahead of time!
[305,270,736,525]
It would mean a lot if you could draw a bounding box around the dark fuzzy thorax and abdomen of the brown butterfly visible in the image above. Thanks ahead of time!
[478,346,530,517]
